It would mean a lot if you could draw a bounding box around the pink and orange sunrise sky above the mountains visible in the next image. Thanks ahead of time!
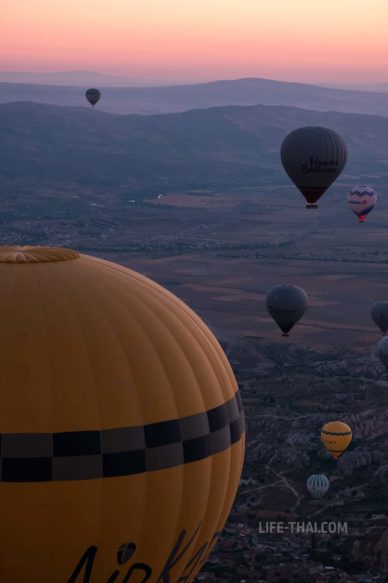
[0,0,388,83]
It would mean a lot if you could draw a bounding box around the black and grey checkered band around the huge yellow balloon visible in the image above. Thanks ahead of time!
[0,391,245,482]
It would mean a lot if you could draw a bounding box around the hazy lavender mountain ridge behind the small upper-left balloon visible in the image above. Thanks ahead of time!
[0,78,388,117]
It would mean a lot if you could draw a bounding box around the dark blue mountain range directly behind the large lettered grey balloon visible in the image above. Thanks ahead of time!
[0,103,388,197]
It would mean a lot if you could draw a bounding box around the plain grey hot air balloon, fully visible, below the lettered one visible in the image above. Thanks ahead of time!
[266,285,308,336]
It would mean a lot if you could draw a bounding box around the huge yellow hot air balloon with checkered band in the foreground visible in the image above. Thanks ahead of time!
[0,247,245,583]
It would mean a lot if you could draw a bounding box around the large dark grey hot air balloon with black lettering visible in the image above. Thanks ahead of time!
[280,127,347,208]
